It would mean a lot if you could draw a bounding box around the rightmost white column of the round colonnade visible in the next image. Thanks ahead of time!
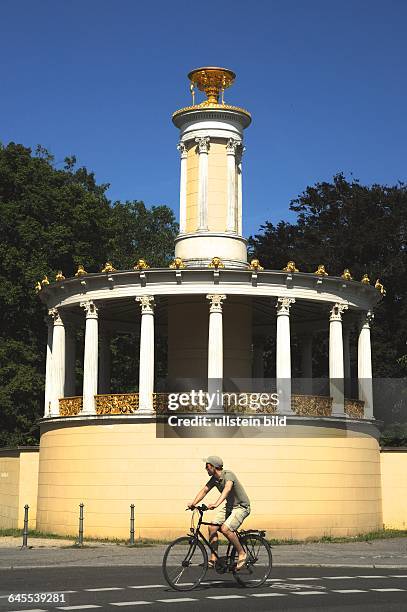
[358,311,374,419]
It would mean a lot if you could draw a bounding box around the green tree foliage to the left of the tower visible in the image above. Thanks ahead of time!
[0,143,177,445]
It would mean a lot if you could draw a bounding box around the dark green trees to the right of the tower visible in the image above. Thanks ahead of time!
[249,174,407,377]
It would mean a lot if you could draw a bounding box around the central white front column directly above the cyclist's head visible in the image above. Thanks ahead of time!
[206,294,226,411]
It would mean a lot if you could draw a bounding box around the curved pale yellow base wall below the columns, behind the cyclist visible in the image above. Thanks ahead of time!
[37,419,382,538]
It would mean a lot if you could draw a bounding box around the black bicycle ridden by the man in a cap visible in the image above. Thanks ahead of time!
[162,504,272,591]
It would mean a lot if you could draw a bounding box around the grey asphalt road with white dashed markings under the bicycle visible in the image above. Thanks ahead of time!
[0,566,407,612]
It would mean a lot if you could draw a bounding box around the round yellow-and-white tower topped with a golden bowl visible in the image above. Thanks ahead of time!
[172,67,251,268]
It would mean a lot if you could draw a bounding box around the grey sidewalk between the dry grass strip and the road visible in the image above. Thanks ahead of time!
[0,537,407,569]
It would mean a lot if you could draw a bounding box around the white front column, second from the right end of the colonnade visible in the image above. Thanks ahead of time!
[329,303,348,416]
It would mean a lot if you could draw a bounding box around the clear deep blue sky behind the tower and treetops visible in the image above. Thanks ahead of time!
[0,0,407,235]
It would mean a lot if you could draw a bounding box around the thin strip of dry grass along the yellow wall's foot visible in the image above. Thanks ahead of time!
[0,529,407,548]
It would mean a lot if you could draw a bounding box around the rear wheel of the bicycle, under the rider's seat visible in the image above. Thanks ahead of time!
[233,533,272,587]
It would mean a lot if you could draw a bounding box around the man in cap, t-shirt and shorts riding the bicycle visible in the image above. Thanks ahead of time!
[188,455,250,570]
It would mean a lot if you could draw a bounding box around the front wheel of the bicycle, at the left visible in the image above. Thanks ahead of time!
[162,536,208,591]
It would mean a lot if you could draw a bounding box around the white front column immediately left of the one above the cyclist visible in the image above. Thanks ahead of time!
[136,295,154,414]
